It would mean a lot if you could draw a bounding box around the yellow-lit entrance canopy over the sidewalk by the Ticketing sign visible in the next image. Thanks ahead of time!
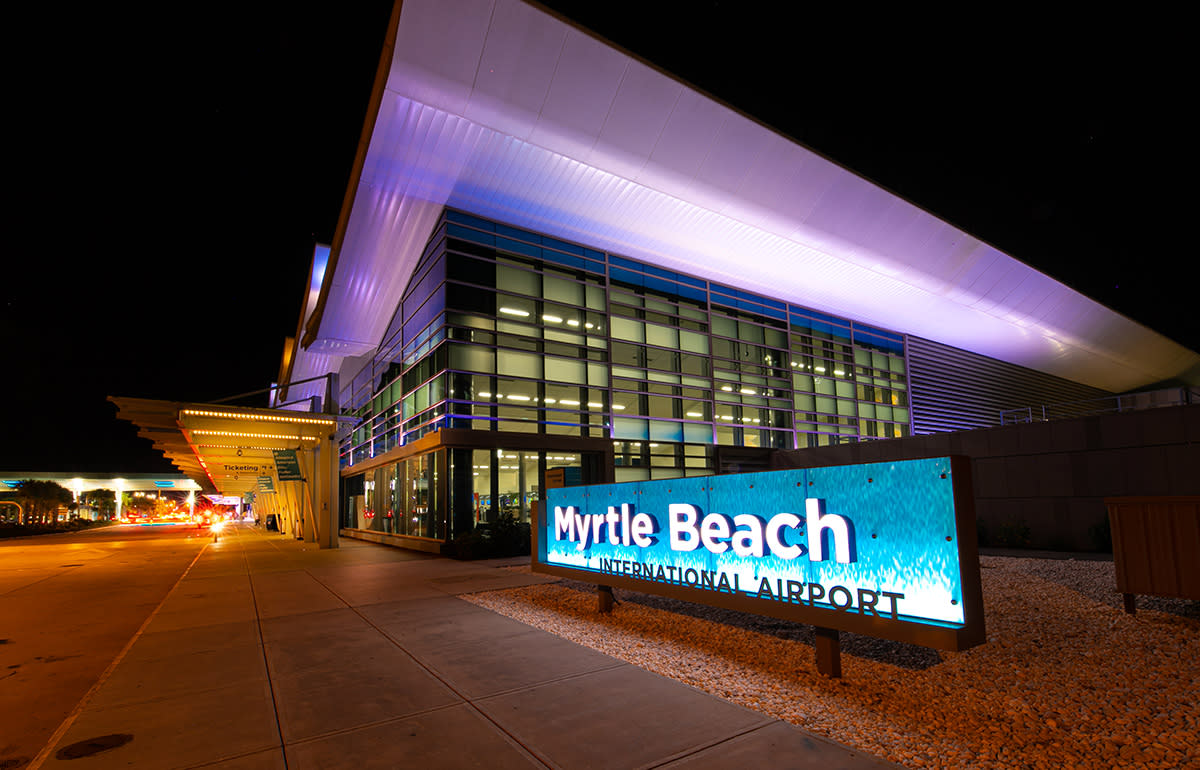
[108,396,336,497]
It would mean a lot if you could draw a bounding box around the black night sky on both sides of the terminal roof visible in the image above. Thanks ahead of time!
[0,0,1200,473]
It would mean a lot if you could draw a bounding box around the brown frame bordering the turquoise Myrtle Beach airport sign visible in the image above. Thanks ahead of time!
[530,455,986,651]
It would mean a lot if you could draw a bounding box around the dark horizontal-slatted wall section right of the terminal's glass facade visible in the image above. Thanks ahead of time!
[906,336,1110,434]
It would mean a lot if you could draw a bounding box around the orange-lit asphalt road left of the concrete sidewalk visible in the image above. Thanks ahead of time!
[0,524,220,770]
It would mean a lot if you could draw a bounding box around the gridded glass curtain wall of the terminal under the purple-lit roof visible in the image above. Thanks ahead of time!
[343,206,910,477]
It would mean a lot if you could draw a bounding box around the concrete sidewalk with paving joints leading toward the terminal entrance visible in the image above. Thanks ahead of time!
[31,525,893,770]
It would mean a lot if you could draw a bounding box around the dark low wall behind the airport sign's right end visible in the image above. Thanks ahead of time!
[772,404,1200,551]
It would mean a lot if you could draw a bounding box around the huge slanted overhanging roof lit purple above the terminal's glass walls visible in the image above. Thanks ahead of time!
[292,0,1200,391]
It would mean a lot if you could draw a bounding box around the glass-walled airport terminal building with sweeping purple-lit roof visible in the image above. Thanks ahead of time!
[276,0,1200,551]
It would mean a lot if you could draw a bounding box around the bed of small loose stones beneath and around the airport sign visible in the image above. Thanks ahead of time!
[463,557,1200,769]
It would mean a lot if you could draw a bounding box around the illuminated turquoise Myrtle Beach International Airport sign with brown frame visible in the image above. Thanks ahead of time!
[534,457,983,649]
